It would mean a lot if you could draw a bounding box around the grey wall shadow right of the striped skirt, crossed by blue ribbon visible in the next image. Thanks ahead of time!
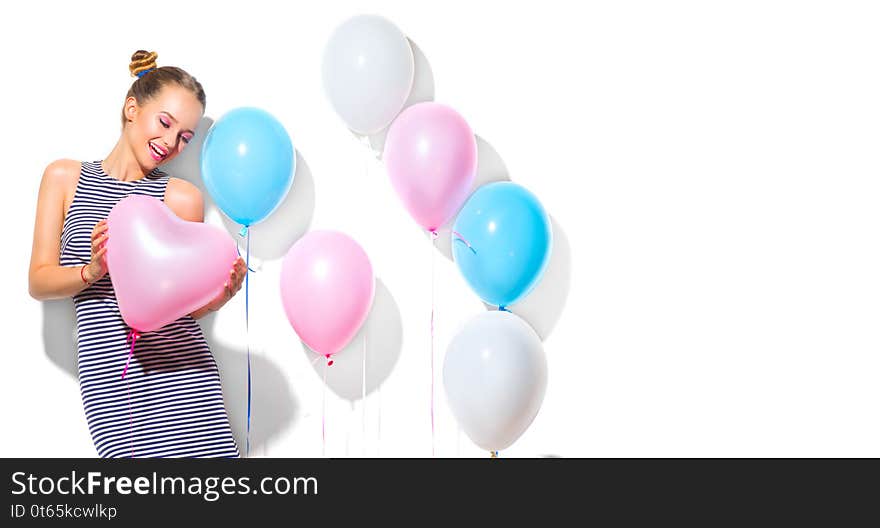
[199,314,300,457]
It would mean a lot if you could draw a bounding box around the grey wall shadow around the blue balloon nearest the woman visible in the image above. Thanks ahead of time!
[165,117,315,269]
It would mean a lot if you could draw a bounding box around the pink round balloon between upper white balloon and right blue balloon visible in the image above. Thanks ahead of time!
[383,103,477,231]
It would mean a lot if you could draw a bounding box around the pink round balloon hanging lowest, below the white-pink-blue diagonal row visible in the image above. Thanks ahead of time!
[281,231,375,356]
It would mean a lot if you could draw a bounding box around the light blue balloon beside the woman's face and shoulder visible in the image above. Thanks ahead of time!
[201,107,295,226]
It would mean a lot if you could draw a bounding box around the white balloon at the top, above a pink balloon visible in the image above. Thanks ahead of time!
[322,15,414,134]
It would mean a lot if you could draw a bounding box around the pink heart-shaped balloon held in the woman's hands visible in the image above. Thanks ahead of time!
[106,194,238,333]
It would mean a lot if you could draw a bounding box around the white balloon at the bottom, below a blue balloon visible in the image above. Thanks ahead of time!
[443,311,547,451]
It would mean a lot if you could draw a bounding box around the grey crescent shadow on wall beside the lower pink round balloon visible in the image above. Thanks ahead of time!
[303,279,403,402]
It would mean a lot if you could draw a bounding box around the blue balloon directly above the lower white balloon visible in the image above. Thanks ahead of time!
[452,182,553,308]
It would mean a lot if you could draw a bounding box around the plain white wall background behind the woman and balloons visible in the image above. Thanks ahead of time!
[0,0,880,457]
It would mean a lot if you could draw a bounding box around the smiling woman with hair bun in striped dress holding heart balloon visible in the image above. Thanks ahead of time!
[29,50,245,457]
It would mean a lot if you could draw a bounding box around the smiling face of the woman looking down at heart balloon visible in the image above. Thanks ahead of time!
[123,84,204,173]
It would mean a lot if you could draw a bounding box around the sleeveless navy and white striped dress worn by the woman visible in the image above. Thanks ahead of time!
[60,161,239,457]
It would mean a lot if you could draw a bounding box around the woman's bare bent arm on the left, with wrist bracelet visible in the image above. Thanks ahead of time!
[28,160,107,301]
